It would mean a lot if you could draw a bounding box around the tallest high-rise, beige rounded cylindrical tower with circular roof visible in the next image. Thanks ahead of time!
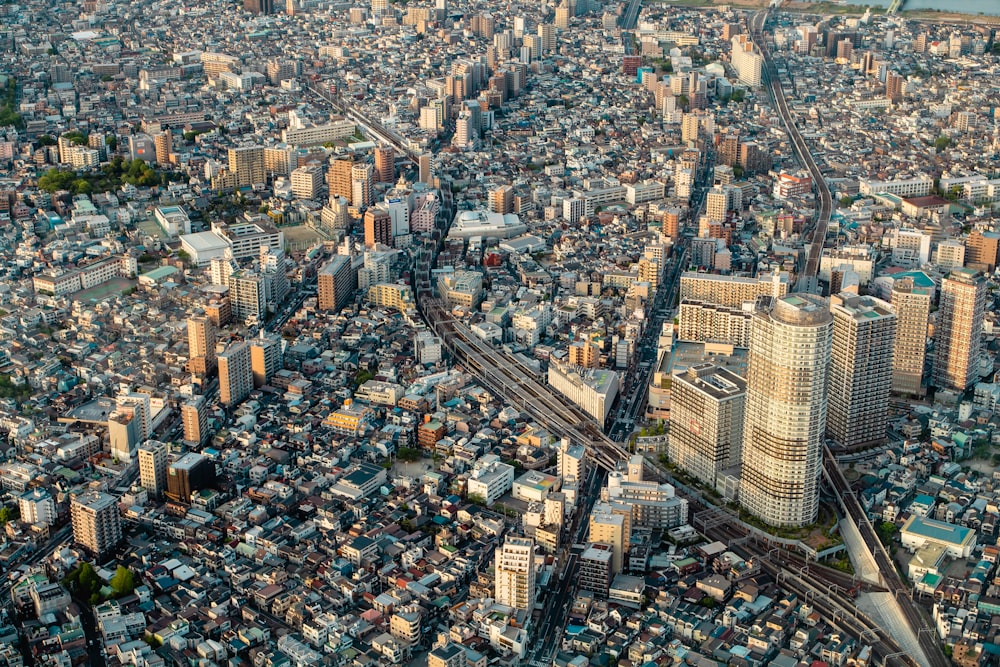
[740,294,833,526]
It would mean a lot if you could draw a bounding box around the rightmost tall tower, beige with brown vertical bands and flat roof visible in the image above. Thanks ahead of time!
[932,269,986,392]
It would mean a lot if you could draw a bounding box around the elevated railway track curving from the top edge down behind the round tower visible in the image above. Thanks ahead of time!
[747,10,833,291]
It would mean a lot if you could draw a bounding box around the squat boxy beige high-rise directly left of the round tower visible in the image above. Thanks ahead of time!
[667,363,747,488]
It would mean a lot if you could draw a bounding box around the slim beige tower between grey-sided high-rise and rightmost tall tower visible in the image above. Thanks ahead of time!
[892,277,934,395]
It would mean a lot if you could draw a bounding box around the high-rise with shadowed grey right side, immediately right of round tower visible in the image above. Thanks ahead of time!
[826,292,896,448]
